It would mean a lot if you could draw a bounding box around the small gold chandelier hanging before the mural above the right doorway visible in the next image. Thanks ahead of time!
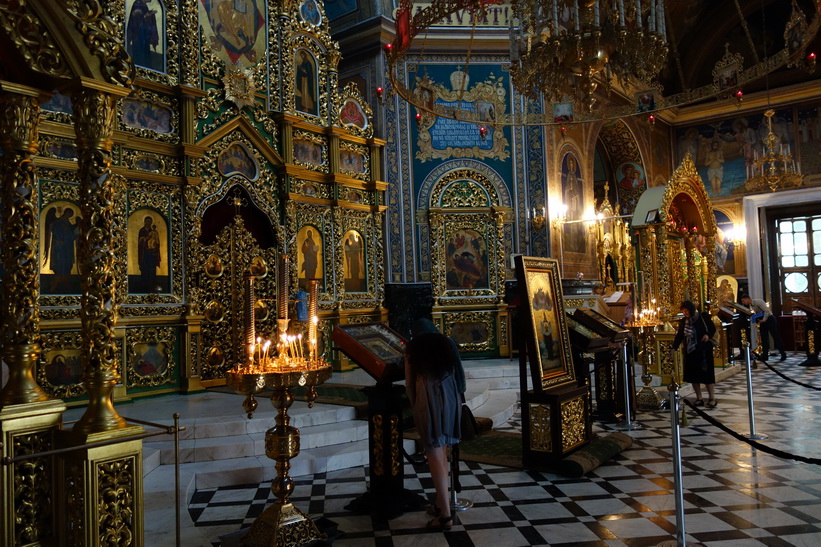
[746,109,804,192]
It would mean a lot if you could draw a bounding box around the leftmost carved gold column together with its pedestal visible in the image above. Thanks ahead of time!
[0,82,66,545]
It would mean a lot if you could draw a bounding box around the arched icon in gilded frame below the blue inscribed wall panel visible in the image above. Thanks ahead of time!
[445,230,489,291]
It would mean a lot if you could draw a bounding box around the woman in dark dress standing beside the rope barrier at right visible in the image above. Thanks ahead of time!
[672,300,718,408]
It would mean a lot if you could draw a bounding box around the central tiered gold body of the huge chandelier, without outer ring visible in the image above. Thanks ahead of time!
[510,0,667,112]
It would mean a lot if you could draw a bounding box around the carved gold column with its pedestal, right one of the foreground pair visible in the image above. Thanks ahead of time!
[57,82,144,546]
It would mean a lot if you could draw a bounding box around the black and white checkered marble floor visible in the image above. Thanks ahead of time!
[188,355,821,547]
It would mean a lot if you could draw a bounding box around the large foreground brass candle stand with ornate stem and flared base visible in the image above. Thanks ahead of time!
[226,355,331,547]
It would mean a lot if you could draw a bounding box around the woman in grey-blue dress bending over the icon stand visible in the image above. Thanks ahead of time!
[405,319,465,530]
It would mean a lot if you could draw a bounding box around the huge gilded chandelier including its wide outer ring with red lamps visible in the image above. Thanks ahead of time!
[386,0,821,126]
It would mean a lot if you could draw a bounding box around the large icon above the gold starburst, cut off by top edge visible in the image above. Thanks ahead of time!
[198,0,265,67]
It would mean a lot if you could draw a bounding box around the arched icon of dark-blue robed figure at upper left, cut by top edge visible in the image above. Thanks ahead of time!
[125,0,165,72]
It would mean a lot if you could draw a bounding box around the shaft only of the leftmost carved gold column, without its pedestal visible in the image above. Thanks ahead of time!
[0,82,48,408]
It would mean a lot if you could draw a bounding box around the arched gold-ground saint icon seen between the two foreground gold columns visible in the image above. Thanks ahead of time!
[40,201,80,294]
